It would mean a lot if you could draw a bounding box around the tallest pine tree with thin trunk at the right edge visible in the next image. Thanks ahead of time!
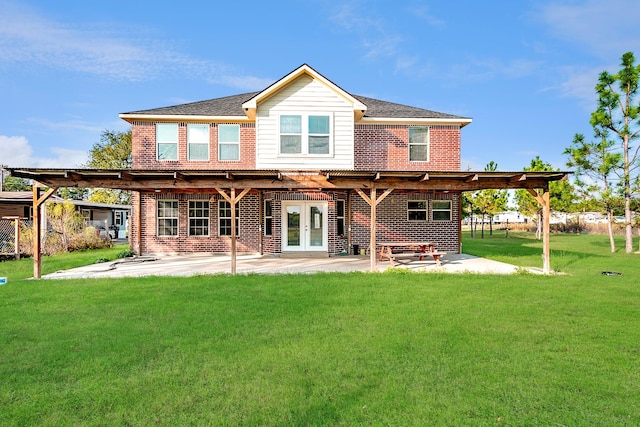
[590,52,640,253]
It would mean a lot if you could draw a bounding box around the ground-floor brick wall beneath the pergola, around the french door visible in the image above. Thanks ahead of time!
[131,190,460,255]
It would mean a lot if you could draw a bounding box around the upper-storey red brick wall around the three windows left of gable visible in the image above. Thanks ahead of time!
[131,121,256,170]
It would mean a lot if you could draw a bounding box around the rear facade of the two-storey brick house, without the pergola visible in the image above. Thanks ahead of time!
[121,64,471,256]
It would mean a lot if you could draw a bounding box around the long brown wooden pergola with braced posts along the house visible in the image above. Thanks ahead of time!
[9,168,568,278]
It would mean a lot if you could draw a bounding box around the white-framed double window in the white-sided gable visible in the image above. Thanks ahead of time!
[279,114,333,155]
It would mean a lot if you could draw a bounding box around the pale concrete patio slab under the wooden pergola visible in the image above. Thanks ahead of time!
[43,254,518,279]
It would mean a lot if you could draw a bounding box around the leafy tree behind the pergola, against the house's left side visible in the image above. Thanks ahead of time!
[86,130,131,205]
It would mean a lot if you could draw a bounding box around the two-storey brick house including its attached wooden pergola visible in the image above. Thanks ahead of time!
[9,64,567,277]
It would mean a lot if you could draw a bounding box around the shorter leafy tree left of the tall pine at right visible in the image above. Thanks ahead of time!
[564,135,622,253]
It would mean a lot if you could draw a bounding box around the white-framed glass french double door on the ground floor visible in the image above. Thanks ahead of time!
[282,201,328,251]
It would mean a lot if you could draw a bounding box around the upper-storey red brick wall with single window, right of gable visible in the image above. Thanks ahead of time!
[354,124,460,171]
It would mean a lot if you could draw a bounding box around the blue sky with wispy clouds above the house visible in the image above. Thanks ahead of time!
[0,0,640,171]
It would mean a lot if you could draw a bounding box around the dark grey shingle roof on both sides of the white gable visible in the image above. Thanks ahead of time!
[124,92,465,119]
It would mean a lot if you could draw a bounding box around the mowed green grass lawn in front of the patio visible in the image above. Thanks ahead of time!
[0,234,640,426]
